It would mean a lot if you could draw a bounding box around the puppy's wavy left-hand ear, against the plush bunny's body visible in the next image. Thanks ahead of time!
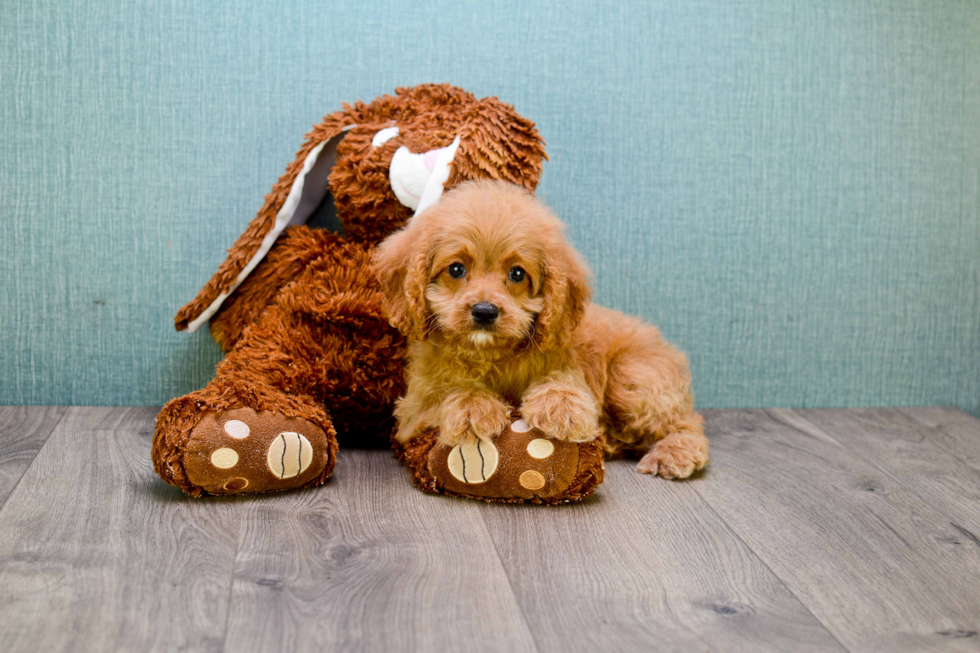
[371,220,429,340]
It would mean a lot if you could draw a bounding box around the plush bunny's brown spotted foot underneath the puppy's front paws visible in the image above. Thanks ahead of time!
[394,419,605,505]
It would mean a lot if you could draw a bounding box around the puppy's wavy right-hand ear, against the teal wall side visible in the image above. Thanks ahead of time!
[534,232,592,350]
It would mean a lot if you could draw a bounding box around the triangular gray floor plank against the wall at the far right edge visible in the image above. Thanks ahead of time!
[770,408,980,544]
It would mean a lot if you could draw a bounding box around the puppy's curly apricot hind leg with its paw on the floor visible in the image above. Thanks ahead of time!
[605,324,708,479]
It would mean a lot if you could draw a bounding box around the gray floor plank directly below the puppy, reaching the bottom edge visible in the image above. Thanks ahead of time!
[484,461,844,653]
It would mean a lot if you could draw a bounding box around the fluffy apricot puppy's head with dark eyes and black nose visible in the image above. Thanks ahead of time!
[374,181,589,349]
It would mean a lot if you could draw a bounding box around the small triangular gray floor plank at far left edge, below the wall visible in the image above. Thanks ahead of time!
[0,406,65,508]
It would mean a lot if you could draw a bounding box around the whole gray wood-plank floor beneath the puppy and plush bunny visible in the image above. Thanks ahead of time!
[0,407,980,653]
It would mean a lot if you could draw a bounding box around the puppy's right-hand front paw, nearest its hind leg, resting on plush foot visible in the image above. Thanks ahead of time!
[521,370,600,442]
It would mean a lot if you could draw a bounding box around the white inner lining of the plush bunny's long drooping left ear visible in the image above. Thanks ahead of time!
[187,125,357,333]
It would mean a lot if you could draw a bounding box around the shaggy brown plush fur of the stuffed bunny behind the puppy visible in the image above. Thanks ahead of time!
[152,85,602,503]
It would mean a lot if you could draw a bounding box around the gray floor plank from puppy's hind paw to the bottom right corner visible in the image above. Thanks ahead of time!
[695,411,980,653]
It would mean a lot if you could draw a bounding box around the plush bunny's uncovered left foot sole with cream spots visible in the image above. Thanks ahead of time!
[184,408,337,494]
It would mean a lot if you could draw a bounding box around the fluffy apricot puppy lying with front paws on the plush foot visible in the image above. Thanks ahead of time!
[374,181,708,478]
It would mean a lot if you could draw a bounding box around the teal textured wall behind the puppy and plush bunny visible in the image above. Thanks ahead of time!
[0,0,980,414]
